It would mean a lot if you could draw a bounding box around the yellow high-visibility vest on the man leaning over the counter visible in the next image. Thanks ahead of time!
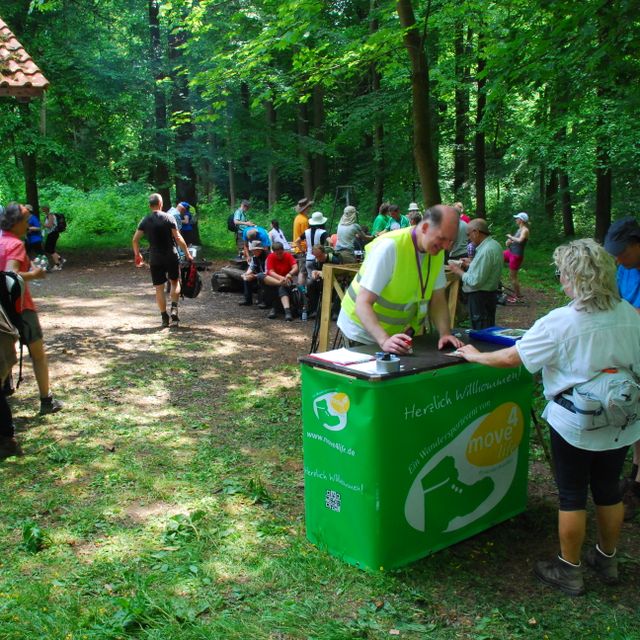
[342,227,444,335]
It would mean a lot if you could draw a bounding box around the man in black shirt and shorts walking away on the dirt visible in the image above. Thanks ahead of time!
[131,193,193,327]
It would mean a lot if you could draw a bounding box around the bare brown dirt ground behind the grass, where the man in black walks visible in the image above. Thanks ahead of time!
[18,250,548,402]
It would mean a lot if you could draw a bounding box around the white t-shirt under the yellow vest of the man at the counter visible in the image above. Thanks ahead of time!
[338,239,447,344]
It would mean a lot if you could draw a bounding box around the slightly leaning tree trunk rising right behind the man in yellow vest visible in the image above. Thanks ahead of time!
[396,0,440,207]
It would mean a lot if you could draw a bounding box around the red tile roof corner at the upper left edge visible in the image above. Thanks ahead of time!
[0,19,49,98]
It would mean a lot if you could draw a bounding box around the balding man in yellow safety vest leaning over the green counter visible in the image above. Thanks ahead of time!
[338,205,462,355]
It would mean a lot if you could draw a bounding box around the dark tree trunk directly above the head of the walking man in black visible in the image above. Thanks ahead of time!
[149,0,171,209]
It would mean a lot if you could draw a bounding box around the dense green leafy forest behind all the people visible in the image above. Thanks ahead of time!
[0,0,640,238]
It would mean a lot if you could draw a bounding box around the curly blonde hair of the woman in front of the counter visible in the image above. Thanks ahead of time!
[553,239,620,313]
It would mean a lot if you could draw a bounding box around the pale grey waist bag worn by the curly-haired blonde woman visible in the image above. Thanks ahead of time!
[555,369,640,430]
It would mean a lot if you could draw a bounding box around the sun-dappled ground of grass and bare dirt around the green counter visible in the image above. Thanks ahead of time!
[0,251,640,640]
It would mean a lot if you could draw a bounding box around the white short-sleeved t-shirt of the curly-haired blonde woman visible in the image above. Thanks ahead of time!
[516,300,640,451]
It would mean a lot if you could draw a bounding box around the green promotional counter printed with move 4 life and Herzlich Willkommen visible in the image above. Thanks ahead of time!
[301,341,533,570]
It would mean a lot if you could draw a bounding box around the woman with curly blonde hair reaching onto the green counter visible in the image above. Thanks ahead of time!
[459,240,640,595]
